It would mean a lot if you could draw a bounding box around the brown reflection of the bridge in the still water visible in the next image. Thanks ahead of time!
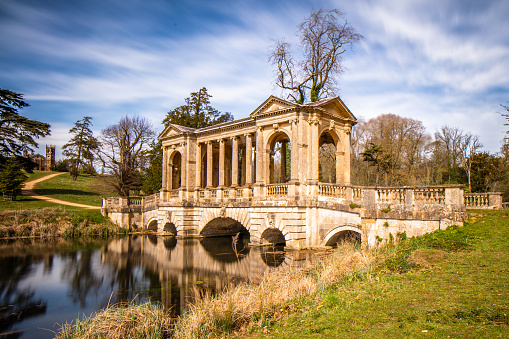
[101,235,313,316]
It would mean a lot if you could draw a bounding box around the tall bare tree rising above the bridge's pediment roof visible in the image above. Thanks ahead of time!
[269,9,362,104]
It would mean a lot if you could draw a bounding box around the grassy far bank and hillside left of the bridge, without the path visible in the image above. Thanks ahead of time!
[0,171,125,238]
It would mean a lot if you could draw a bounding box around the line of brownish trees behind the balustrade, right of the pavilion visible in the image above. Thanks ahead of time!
[352,113,509,197]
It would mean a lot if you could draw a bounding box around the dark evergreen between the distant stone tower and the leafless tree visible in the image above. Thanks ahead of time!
[62,117,99,180]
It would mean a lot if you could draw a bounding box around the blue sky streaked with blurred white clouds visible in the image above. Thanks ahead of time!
[0,0,509,158]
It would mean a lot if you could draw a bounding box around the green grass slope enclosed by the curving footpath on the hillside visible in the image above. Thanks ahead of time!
[34,173,115,206]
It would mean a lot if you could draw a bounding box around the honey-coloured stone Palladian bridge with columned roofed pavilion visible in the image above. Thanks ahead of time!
[103,96,466,248]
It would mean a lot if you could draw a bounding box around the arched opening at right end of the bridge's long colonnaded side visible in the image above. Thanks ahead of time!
[265,129,291,184]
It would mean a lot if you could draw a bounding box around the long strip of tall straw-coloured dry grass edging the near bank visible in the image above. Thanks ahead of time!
[173,245,374,339]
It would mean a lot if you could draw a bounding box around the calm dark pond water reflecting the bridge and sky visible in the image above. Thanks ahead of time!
[0,236,311,339]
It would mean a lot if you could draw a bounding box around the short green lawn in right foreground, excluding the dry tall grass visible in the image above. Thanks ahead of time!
[250,211,509,338]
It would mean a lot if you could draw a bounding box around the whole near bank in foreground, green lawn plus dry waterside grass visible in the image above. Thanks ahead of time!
[55,211,509,338]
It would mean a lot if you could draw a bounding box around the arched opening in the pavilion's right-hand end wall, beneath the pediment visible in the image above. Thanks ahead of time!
[318,131,337,184]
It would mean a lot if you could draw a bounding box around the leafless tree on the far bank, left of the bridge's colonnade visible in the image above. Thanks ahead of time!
[98,116,156,197]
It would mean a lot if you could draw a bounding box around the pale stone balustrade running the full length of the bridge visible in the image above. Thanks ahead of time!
[103,183,464,214]
